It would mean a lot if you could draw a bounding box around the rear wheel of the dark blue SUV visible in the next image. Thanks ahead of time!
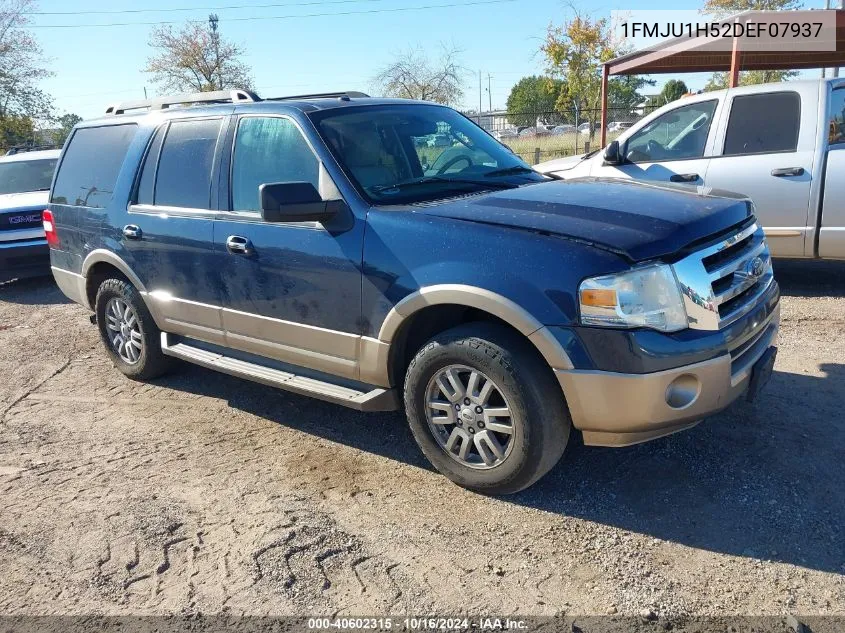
[95,279,171,380]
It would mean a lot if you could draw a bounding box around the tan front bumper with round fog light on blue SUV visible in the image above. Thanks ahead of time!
[555,305,780,446]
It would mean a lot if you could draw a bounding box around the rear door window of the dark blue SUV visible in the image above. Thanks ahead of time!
[152,119,221,209]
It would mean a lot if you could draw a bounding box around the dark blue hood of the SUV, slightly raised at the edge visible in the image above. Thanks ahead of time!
[417,178,753,261]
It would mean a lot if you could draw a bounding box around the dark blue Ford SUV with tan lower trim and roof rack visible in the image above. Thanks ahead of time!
[45,91,779,493]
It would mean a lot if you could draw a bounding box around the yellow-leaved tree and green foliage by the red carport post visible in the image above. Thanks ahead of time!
[540,12,654,137]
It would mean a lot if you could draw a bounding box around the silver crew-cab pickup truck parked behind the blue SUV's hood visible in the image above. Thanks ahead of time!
[535,79,845,259]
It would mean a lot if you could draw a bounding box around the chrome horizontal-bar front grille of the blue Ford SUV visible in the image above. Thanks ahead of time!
[674,223,773,330]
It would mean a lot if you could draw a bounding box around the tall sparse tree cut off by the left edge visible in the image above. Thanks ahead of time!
[0,0,52,147]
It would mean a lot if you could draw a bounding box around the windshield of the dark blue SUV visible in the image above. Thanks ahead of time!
[312,104,548,204]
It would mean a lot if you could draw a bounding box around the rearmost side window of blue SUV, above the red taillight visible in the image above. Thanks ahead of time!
[50,123,138,209]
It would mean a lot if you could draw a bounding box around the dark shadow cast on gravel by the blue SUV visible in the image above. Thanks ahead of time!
[162,350,845,573]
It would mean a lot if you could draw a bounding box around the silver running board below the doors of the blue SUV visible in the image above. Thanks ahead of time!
[161,332,399,411]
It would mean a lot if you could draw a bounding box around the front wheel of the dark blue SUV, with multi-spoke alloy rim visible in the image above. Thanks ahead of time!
[405,323,571,494]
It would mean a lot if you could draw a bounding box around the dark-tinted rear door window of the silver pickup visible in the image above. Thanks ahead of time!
[723,92,801,156]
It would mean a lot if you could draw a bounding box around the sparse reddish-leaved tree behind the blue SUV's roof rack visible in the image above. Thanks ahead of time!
[143,16,252,93]
